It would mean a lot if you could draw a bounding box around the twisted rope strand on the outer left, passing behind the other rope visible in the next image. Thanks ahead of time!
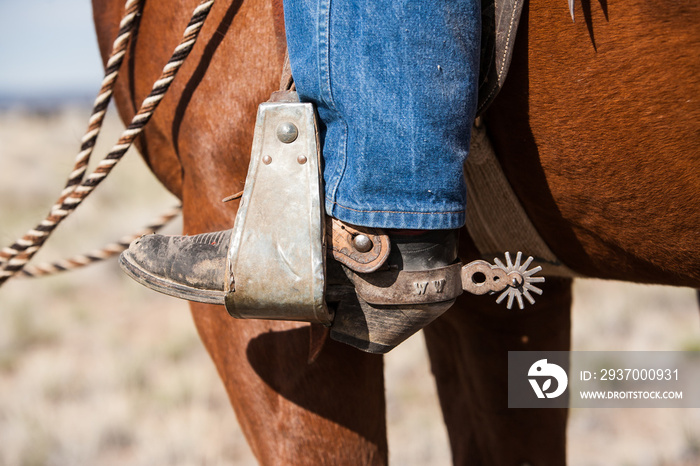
[0,0,143,266]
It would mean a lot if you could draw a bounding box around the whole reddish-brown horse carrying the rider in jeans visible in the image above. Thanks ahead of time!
[93,0,700,465]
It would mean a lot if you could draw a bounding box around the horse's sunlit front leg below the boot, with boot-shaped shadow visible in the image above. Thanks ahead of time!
[192,304,387,464]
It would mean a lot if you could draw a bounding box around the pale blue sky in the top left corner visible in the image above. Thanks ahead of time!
[0,0,102,98]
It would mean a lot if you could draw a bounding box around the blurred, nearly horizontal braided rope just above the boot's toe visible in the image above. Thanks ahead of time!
[19,206,182,278]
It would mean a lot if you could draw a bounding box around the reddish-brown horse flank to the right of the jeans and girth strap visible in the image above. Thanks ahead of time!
[487,0,700,287]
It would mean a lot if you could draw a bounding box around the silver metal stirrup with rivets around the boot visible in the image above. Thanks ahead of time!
[225,92,333,325]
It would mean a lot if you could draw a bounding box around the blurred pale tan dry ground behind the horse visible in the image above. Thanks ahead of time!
[0,108,700,466]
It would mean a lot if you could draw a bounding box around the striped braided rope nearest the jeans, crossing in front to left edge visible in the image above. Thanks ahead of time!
[0,0,214,286]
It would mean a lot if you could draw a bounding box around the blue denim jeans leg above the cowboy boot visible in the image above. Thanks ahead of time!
[284,0,481,229]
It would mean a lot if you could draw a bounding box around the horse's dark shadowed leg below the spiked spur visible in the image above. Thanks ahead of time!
[424,233,571,465]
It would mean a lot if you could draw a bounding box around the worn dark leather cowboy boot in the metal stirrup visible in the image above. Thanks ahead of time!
[119,224,462,353]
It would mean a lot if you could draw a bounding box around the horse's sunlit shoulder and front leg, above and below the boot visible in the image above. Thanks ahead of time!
[93,0,387,464]
